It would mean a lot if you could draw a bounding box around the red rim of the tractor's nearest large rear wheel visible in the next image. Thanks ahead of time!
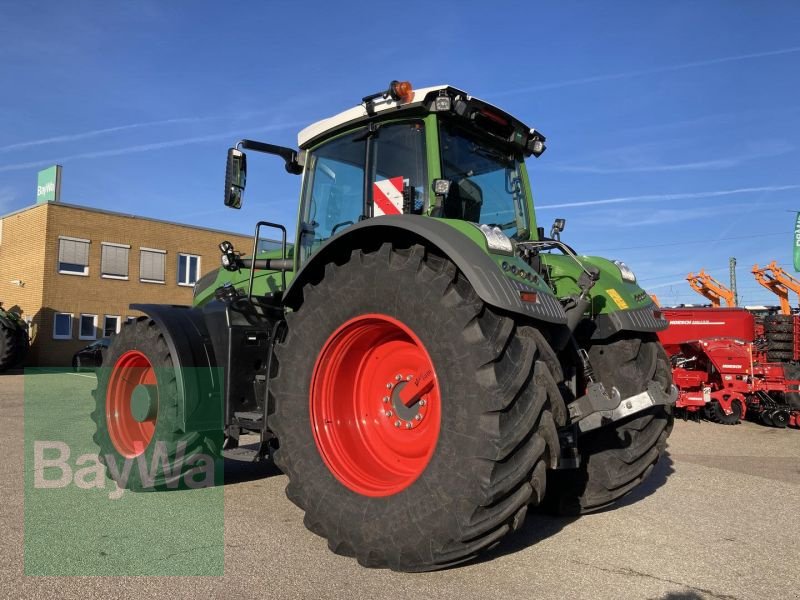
[309,314,441,497]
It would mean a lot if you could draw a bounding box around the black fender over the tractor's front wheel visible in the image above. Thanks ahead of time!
[130,304,224,432]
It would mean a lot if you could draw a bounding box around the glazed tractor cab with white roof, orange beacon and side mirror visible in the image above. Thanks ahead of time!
[216,81,545,269]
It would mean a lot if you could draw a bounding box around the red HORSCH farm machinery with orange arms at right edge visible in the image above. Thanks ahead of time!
[659,262,800,427]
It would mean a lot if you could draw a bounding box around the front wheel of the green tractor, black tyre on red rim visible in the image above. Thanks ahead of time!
[92,317,222,491]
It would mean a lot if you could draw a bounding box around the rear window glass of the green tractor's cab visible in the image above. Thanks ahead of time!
[439,121,528,239]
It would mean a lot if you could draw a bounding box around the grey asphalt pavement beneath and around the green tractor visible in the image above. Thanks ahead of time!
[0,374,800,600]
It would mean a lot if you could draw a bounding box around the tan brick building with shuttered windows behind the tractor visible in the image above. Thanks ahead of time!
[0,202,252,366]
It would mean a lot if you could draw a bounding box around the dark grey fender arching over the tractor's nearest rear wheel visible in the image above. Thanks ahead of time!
[284,215,567,325]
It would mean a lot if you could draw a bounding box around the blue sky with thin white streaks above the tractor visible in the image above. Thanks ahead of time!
[0,0,800,304]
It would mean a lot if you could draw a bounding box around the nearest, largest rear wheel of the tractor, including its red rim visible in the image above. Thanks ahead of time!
[270,244,566,571]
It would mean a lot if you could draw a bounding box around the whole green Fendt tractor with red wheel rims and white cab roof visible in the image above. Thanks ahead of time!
[93,81,677,571]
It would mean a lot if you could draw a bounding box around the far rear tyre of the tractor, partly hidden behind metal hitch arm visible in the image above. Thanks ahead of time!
[547,333,673,514]
